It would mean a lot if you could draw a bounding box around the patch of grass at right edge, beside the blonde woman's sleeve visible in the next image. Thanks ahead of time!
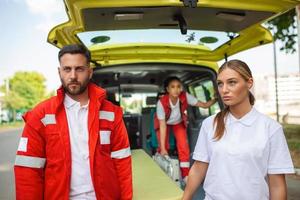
[283,124,300,168]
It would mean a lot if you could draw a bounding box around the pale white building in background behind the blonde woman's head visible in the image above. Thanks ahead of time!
[253,73,300,124]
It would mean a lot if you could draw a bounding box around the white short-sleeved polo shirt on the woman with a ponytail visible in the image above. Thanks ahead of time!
[193,108,294,200]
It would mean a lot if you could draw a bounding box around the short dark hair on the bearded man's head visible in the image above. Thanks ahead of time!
[58,44,91,63]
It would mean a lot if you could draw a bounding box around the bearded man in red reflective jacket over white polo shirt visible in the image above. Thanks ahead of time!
[15,45,132,200]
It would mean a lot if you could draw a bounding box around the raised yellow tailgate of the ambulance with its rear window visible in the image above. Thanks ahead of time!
[48,0,299,66]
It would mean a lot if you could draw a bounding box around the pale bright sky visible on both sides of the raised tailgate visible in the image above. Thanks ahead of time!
[0,0,299,90]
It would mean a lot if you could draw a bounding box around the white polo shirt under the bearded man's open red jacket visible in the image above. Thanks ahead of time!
[64,95,96,199]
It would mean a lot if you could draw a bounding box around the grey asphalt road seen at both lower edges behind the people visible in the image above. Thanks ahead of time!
[0,129,300,200]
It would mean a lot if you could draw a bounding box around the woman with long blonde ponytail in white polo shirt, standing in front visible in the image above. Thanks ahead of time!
[183,60,294,200]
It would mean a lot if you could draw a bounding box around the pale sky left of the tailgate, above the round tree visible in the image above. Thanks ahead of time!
[0,0,67,89]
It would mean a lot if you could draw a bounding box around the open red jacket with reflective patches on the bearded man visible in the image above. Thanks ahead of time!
[14,83,132,200]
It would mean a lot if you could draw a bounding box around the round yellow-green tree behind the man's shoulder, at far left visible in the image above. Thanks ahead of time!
[2,71,46,119]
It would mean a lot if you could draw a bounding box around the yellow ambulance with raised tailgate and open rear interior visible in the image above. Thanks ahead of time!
[48,0,299,200]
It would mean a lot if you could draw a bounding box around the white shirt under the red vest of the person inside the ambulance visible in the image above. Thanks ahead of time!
[156,92,198,125]
